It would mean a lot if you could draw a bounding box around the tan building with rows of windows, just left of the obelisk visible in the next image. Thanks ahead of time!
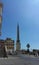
[5,38,14,54]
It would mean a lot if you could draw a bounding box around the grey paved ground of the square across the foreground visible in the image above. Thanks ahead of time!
[0,54,39,65]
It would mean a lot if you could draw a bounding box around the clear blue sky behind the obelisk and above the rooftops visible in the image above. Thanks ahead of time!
[0,0,39,49]
